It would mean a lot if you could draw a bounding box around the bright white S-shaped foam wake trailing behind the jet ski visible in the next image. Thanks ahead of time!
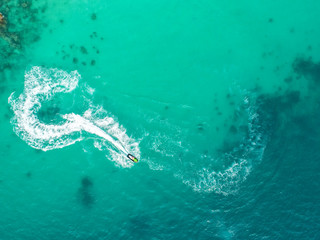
[8,67,140,167]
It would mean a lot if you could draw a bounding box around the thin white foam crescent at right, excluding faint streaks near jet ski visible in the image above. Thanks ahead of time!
[176,96,268,195]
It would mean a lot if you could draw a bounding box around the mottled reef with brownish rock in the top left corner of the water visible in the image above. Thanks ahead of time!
[0,0,47,87]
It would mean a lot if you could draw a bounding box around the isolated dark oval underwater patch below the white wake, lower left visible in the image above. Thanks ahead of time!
[78,176,95,208]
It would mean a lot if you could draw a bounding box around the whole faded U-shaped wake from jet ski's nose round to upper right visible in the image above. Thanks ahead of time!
[146,89,269,195]
